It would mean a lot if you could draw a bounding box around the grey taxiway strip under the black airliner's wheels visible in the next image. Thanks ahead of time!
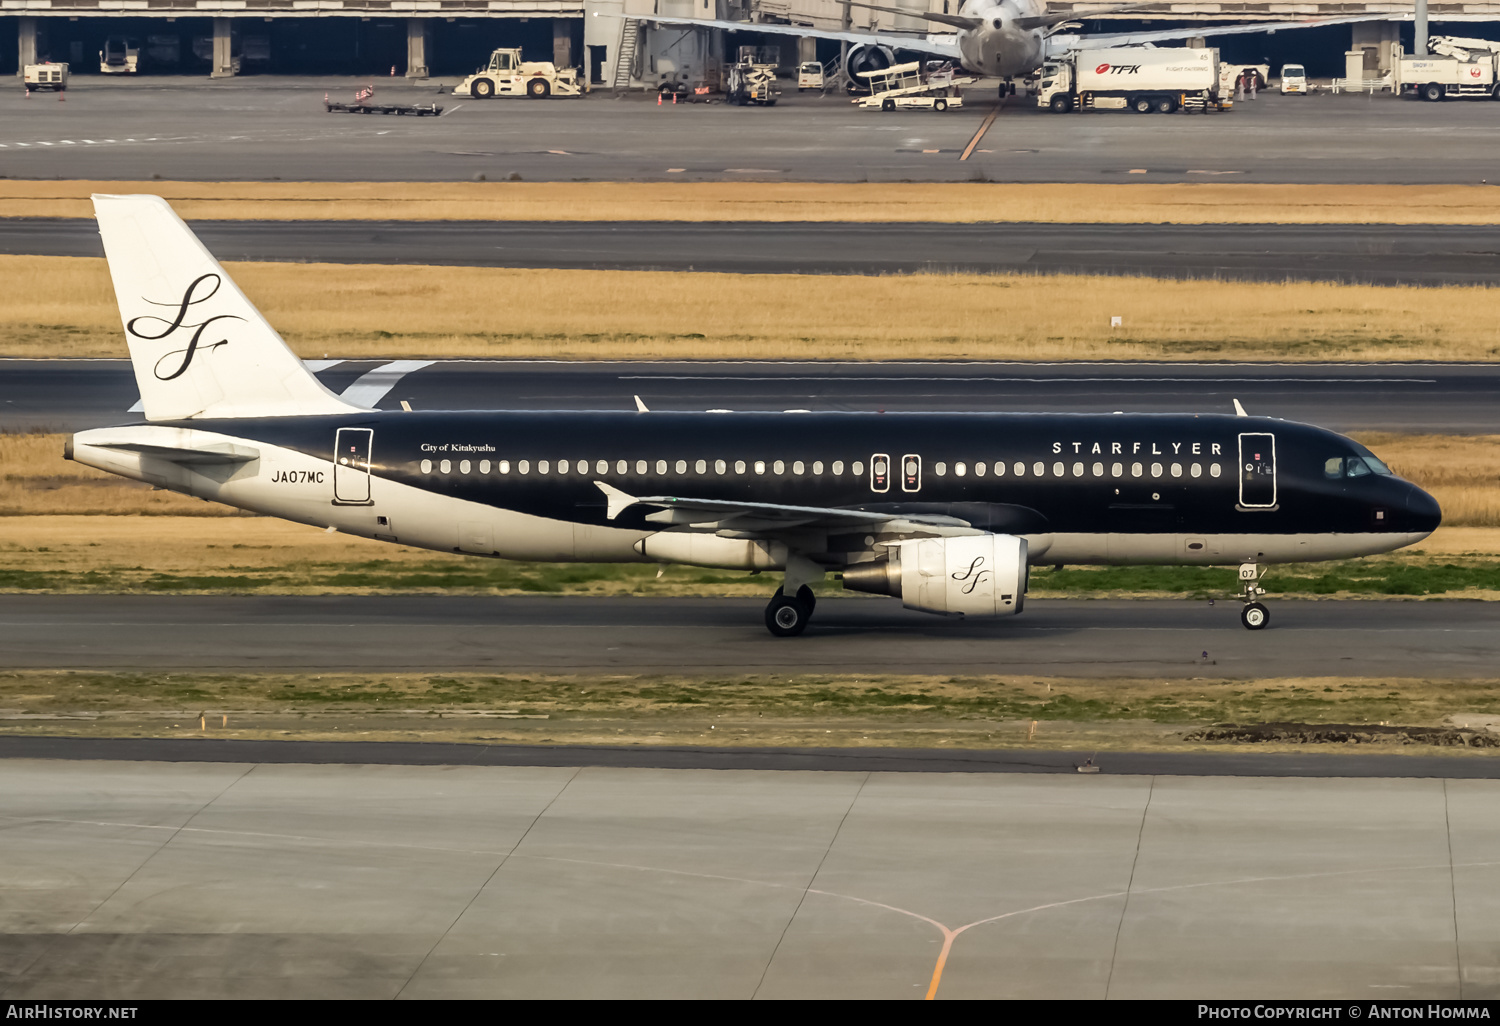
[0,585,1500,678]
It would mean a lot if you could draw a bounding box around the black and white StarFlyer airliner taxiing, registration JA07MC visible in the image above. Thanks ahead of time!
[68,197,1442,636]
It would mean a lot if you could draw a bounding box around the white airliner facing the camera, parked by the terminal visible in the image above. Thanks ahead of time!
[639,0,1391,84]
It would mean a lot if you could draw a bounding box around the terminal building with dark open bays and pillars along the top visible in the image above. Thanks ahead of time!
[0,0,1500,81]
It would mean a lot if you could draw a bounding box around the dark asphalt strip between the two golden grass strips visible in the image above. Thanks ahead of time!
[11,218,1500,285]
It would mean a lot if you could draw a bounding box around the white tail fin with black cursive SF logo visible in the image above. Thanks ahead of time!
[93,195,360,420]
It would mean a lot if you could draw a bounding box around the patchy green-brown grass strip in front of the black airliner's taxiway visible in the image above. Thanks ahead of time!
[0,671,1500,758]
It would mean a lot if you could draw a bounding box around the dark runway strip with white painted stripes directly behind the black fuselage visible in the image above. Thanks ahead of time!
[0,357,1500,434]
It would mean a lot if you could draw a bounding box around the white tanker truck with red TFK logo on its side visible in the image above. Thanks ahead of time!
[1037,47,1233,114]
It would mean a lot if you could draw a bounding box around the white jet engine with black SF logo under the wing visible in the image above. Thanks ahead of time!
[843,534,1028,617]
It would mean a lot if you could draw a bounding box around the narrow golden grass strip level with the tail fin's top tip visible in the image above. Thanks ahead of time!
[0,182,1500,225]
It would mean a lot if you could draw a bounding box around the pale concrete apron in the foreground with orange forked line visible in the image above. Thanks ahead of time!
[0,759,1500,1001]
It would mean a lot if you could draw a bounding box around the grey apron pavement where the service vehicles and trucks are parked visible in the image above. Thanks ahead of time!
[0,77,1496,183]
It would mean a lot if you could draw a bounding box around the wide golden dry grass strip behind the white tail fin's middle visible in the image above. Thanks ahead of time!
[0,257,1500,360]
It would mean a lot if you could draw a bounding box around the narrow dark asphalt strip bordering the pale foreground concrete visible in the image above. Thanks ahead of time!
[0,735,1500,780]
